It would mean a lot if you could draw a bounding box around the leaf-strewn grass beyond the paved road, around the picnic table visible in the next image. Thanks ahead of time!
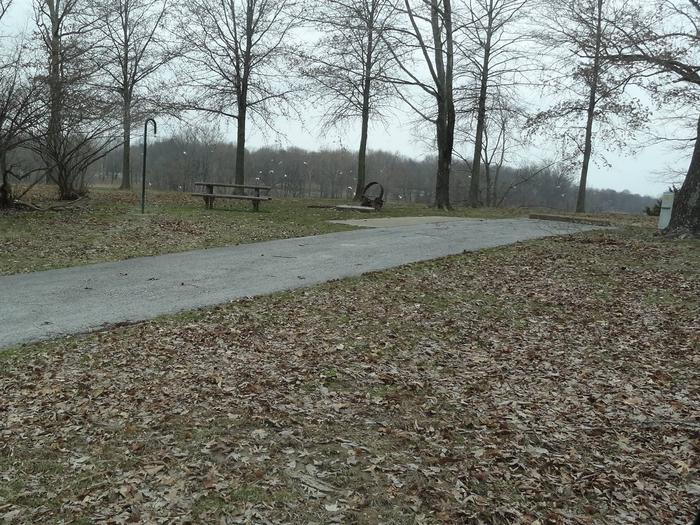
[0,184,656,275]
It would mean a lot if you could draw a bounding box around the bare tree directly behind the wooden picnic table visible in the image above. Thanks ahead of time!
[178,0,300,188]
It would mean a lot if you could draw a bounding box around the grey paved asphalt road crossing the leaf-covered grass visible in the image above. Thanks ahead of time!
[0,219,593,347]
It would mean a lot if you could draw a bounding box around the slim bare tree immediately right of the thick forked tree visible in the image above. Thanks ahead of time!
[459,0,531,206]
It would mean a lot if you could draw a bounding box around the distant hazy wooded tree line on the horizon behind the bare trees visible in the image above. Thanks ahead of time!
[82,137,655,213]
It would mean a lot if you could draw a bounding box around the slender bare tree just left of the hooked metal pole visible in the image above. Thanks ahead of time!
[91,0,177,189]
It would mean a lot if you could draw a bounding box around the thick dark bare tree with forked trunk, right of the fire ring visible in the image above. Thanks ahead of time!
[388,0,456,210]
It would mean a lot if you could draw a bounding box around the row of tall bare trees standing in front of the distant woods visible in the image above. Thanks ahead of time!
[0,0,700,233]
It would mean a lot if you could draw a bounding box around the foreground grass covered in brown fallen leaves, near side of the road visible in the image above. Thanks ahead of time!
[0,227,700,525]
